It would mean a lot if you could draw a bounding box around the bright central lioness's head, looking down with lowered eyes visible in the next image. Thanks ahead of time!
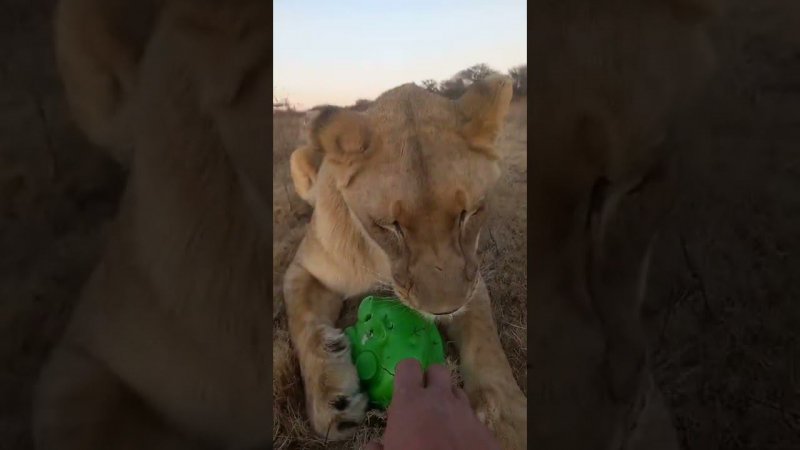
[292,76,512,314]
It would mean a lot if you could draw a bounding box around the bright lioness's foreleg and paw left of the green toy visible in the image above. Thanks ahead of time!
[283,263,367,440]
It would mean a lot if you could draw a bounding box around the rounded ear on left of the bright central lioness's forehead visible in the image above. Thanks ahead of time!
[311,107,375,163]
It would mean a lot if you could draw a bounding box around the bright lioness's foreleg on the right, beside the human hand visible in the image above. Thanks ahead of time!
[446,280,528,449]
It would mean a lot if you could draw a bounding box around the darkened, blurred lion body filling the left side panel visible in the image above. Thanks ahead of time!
[34,0,272,450]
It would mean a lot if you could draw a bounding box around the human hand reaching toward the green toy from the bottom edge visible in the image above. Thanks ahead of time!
[364,359,500,450]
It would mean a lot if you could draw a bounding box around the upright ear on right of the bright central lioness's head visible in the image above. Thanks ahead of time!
[457,75,513,158]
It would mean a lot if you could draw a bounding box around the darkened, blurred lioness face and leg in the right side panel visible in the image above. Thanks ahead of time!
[528,0,716,450]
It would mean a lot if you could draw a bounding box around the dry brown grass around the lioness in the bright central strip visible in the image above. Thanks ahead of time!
[272,101,528,449]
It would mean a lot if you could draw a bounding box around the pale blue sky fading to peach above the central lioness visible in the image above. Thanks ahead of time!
[273,0,527,109]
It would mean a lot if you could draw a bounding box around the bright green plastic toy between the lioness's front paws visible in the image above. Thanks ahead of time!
[344,296,445,409]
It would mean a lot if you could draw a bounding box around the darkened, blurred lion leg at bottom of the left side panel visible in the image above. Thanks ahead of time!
[33,346,202,450]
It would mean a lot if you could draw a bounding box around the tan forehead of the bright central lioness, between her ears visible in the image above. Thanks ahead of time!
[348,84,499,210]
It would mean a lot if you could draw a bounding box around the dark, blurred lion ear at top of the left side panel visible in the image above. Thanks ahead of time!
[55,0,163,164]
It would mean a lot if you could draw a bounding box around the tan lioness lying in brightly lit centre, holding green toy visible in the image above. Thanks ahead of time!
[283,75,527,449]
